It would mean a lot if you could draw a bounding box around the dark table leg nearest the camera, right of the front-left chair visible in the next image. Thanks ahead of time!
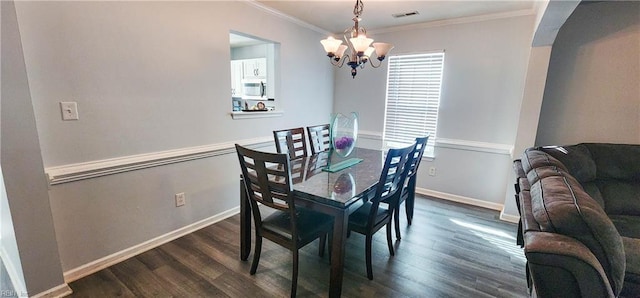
[329,210,349,297]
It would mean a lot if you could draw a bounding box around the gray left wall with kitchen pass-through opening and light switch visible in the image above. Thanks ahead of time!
[12,1,333,273]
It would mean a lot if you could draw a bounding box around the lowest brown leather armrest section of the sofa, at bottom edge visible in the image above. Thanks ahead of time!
[524,231,615,297]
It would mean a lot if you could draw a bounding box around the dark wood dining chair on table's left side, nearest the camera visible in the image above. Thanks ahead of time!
[236,144,333,297]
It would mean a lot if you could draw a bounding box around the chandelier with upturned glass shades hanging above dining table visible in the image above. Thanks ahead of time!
[320,0,393,79]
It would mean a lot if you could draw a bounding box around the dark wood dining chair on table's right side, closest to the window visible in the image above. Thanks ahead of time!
[393,135,429,239]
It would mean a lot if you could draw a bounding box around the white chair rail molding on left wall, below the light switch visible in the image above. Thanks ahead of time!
[45,137,273,185]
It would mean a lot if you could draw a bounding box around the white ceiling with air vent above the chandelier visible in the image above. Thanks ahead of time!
[256,0,540,33]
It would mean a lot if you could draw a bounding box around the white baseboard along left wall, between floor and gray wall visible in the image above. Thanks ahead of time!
[64,206,240,283]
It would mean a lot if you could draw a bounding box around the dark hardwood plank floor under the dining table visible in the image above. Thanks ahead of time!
[70,197,527,298]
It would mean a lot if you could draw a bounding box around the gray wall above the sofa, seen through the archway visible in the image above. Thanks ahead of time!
[536,1,640,145]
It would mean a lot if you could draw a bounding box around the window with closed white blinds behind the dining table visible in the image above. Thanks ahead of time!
[382,52,444,156]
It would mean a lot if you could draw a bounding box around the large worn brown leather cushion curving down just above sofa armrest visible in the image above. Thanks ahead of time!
[530,171,625,295]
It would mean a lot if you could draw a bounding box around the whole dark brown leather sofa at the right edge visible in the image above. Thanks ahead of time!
[514,143,640,297]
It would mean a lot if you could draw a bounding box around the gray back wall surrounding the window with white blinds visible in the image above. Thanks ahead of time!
[334,13,535,209]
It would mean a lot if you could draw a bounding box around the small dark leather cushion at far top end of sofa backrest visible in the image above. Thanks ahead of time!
[539,144,596,183]
